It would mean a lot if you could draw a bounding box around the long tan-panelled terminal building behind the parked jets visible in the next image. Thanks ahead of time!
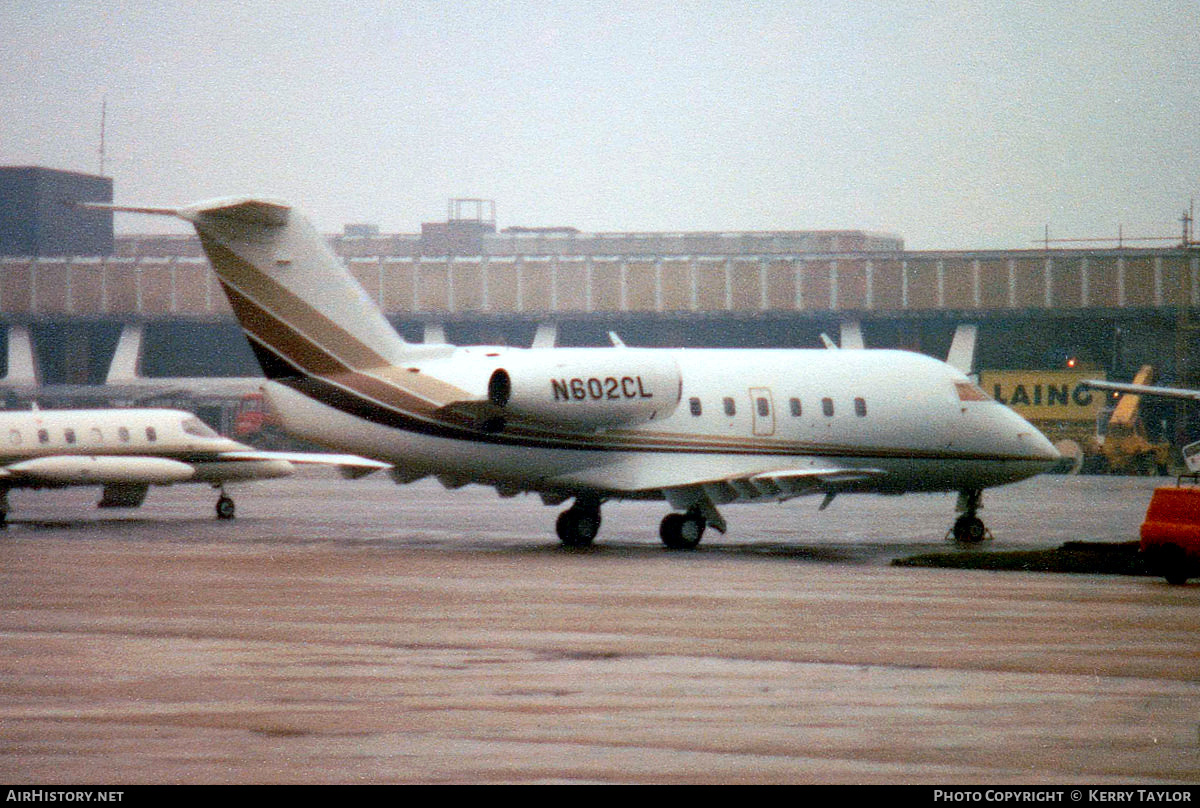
[0,170,1200,463]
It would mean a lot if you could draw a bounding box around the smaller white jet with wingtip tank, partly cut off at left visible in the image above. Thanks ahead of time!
[0,406,388,527]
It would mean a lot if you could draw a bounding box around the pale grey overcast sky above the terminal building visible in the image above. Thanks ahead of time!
[0,0,1200,250]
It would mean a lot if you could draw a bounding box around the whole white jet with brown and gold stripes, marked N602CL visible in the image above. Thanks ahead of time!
[103,197,1058,549]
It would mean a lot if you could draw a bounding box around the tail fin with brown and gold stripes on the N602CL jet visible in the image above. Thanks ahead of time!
[176,197,441,378]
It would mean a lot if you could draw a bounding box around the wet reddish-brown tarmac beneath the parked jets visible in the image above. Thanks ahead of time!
[0,475,1200,784]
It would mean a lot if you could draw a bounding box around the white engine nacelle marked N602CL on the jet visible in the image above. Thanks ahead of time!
[487,348,683,430]
